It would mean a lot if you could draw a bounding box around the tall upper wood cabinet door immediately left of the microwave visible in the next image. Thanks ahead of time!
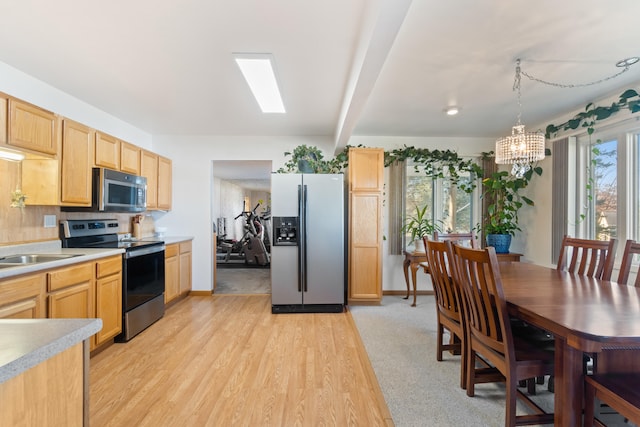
[60,119,95,206]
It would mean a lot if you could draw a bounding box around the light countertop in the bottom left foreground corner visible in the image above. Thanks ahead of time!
[0,319,102,383]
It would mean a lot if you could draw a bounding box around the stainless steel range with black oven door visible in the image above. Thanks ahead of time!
[60,219,165,342]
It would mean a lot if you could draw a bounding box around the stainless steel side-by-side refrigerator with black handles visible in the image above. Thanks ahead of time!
[271,174,346,313]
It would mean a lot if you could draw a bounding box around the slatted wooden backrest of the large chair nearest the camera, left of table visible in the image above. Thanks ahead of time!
[450,244,515,366]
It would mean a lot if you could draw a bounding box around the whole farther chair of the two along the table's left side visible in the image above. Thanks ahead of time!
[424,237,467,388]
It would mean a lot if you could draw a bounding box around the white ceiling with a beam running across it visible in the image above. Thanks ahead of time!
[0,0,640,179]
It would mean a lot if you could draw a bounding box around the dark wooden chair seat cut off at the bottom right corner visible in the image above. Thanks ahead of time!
[584,373,640,427]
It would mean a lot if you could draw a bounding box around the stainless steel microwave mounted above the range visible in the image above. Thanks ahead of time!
[62,168,147,212]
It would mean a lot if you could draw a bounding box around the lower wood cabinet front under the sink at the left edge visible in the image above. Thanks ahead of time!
[0,274,46,319]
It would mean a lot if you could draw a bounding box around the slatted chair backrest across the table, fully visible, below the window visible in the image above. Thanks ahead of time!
[557,236,616,280]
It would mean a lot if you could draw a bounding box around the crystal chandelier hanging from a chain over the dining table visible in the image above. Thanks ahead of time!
[496,59,545,178]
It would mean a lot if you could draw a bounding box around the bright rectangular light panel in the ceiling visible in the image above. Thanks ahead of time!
[233,53,285,113]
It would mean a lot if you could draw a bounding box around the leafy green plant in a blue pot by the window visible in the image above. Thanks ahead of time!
[481,167,542,253]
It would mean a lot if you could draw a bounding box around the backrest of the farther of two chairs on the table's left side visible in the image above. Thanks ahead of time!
[424,237,462,322]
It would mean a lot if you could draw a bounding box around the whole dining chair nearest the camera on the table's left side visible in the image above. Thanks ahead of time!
[449,245,554,426]
